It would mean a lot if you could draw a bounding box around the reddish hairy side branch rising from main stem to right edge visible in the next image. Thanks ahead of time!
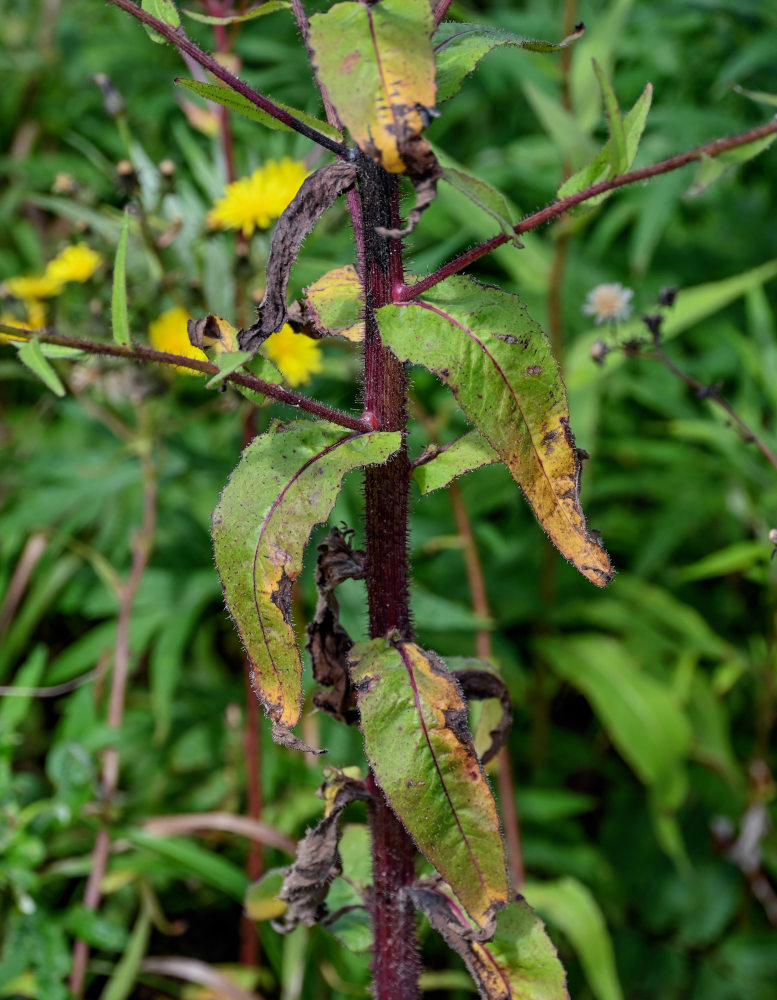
[398,117,777,303]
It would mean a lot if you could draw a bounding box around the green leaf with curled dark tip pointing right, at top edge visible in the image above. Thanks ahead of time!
[432,22,583,104]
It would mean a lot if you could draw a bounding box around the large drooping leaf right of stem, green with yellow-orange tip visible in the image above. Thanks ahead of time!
[377,276,612,586]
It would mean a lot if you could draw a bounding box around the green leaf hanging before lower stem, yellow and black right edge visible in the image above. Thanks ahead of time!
[349,639,508,927]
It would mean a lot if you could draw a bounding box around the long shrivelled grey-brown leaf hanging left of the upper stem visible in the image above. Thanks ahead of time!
[238,161,356,351]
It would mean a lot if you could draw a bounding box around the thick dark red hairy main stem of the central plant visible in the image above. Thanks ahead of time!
[357,155,420,1000]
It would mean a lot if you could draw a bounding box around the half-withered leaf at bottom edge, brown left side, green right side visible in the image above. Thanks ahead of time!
[409,886,569,1000]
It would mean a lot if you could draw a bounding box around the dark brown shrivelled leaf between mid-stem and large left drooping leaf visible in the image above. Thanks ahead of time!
[306,528,366,725]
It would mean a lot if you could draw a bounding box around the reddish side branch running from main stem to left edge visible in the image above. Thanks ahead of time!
[0,323,375,434]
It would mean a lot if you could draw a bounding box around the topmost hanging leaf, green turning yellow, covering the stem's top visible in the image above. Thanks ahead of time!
[309,0,435,175]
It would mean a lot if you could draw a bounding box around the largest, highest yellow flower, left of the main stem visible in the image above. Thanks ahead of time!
[208,156,308,238]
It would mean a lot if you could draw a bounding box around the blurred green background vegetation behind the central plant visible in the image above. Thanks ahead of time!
[0,0,777,1000]
